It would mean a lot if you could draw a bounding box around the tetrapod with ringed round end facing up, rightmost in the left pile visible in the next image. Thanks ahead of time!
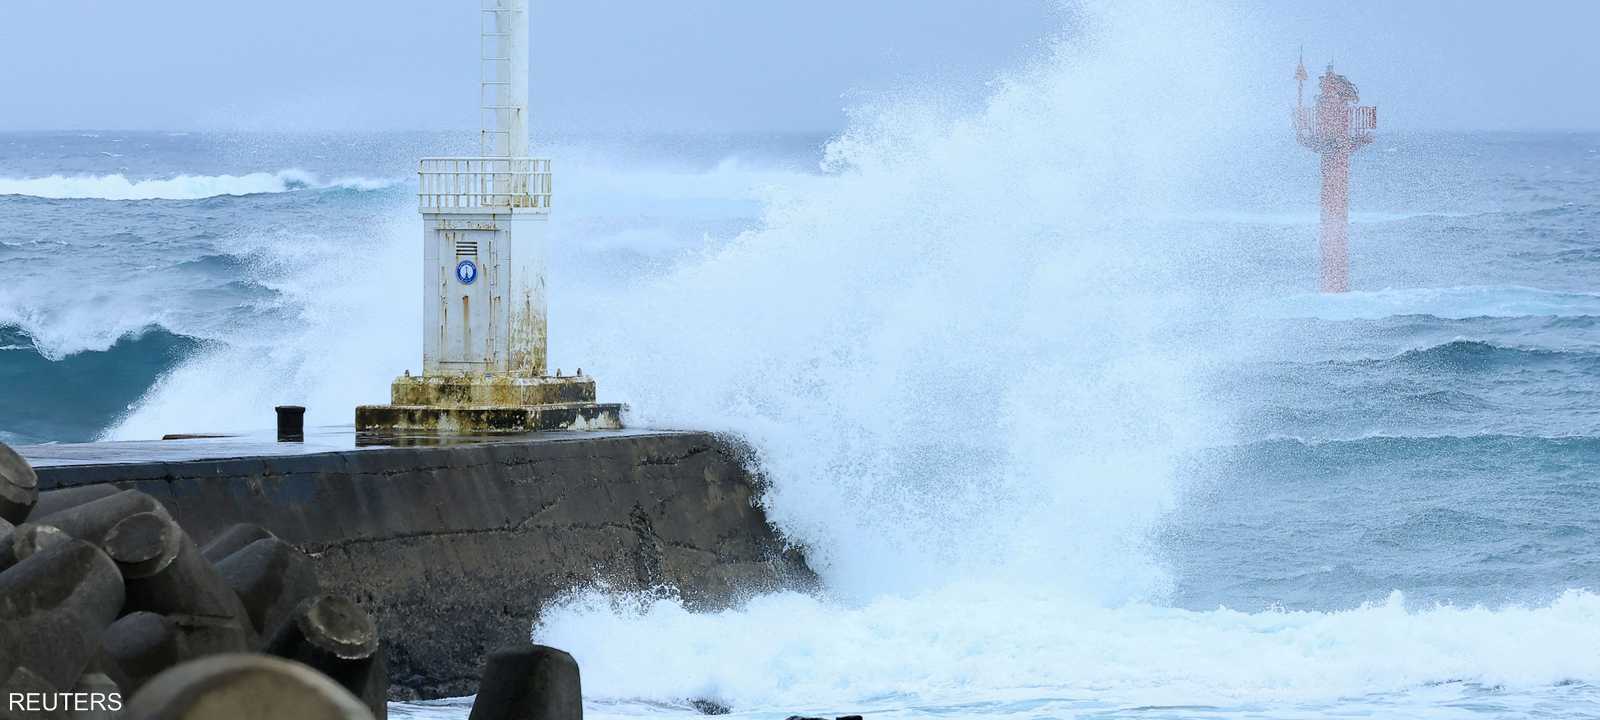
[267,595,389,718]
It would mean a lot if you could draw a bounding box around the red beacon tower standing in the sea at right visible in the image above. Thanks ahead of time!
[1294,58,1378,293]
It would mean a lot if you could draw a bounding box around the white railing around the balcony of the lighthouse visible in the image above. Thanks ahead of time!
[416,157,550,211]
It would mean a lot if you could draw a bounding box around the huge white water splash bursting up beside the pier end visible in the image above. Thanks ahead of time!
[555,0,1232,602]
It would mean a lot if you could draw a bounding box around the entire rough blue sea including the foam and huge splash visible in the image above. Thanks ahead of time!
[0,3,1600,718]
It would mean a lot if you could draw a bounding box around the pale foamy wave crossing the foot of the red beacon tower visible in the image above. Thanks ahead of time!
[1253,285,1600,320]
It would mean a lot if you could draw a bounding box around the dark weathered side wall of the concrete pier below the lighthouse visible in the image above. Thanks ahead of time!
[24,432,814,698]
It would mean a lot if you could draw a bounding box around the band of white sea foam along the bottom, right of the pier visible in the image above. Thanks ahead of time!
[533,584,1600,717]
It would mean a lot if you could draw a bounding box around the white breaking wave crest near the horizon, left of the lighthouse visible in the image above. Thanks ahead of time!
[0,168,403,200]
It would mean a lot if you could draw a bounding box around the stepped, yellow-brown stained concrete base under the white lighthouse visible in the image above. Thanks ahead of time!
[355,374,624,435]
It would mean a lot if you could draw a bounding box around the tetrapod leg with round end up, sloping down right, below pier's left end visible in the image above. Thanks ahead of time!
[104,512,254,648]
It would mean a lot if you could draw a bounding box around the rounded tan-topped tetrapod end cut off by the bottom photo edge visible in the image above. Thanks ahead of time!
[125,654,373,720]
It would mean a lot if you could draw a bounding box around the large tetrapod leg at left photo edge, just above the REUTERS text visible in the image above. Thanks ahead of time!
[0,539,123,688]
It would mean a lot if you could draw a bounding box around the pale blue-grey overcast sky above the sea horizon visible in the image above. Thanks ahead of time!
[0,0,1600,133]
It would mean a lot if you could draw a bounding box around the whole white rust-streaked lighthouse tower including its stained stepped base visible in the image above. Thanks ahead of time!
[355,0,621,434]
